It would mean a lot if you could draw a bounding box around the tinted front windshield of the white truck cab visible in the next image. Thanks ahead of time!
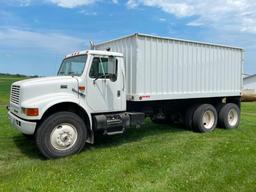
[58,55,87,76]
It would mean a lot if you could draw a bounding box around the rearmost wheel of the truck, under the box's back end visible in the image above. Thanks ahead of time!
[219,103,240,129]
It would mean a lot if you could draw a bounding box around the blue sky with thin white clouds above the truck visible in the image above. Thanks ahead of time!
[0,0,256,76]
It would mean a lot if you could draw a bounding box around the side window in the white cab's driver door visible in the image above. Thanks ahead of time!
[89,57,118,81]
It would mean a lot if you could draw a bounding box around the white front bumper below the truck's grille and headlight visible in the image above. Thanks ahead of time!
[8,111,36,135]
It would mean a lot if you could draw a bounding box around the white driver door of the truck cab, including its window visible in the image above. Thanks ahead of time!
[86,55,125,113]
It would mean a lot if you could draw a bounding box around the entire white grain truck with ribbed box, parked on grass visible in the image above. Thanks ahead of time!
[8,33,243,158]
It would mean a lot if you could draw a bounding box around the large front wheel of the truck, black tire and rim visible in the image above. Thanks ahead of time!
[36,112,87,159]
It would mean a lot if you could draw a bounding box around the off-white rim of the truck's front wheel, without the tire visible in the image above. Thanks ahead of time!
[50,123,77,151]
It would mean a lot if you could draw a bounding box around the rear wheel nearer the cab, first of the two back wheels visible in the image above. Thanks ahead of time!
[193,104,218,133]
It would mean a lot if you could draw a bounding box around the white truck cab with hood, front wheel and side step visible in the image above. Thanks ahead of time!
[8,50,143,158]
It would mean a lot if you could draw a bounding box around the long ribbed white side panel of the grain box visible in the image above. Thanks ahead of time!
[134,36,242,100]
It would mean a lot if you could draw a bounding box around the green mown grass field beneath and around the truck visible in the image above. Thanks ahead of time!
[0,78,256,192]
